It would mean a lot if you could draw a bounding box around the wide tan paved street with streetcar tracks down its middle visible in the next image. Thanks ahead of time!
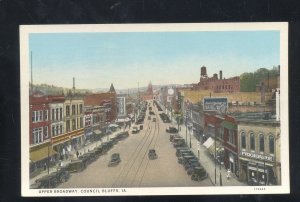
[57,100,212,188]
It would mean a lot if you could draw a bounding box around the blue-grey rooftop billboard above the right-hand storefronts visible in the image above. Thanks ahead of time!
[203,97,228,113]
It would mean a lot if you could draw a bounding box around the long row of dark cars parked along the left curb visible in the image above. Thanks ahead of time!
[30,131,129,189]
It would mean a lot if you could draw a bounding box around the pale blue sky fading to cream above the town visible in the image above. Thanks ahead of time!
[29,31,280,89]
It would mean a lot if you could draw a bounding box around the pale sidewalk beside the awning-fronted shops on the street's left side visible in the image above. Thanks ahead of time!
[30,128,130,184]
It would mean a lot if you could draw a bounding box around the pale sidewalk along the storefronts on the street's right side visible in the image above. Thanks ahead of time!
[172,120,247,186]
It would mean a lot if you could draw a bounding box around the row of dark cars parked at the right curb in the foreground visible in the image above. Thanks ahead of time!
[170,134,208,181]
